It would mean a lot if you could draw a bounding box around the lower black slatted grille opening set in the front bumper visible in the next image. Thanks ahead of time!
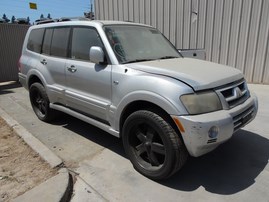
[233,106,254,132]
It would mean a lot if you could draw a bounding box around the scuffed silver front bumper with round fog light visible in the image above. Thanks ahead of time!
[176,92,258,157]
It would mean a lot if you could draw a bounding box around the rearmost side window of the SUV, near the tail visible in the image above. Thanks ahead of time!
[27,29,44,53]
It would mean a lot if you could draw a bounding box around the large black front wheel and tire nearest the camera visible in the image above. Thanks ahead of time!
[122,110,188,180]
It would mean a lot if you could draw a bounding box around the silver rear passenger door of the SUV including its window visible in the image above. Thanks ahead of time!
[40,27,71,104]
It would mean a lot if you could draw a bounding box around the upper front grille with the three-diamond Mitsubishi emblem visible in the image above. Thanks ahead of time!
[217,80,249,109]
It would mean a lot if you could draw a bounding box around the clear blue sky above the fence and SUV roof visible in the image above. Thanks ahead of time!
[0,0,94,23]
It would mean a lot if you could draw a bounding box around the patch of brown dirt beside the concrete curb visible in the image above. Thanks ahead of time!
[0,117,57,202]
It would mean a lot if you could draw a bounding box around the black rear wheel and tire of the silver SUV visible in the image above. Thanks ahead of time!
[29,83,57,122]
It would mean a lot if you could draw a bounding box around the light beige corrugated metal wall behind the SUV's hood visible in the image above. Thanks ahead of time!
[95,0,269,84]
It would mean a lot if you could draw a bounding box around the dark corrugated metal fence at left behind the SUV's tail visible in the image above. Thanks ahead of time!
[0,24,29,82]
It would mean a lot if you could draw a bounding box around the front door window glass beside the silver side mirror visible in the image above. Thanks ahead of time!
[71,27,103,60]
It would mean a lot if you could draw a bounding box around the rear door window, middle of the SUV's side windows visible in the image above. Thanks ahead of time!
[50,27,70,57]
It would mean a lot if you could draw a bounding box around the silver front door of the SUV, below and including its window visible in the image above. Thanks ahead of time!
[66,26,111,123]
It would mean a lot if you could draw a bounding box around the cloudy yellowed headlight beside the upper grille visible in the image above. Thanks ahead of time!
[180,91,222,114]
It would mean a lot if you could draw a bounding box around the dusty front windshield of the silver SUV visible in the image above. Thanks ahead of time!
[104,25,180,64]
